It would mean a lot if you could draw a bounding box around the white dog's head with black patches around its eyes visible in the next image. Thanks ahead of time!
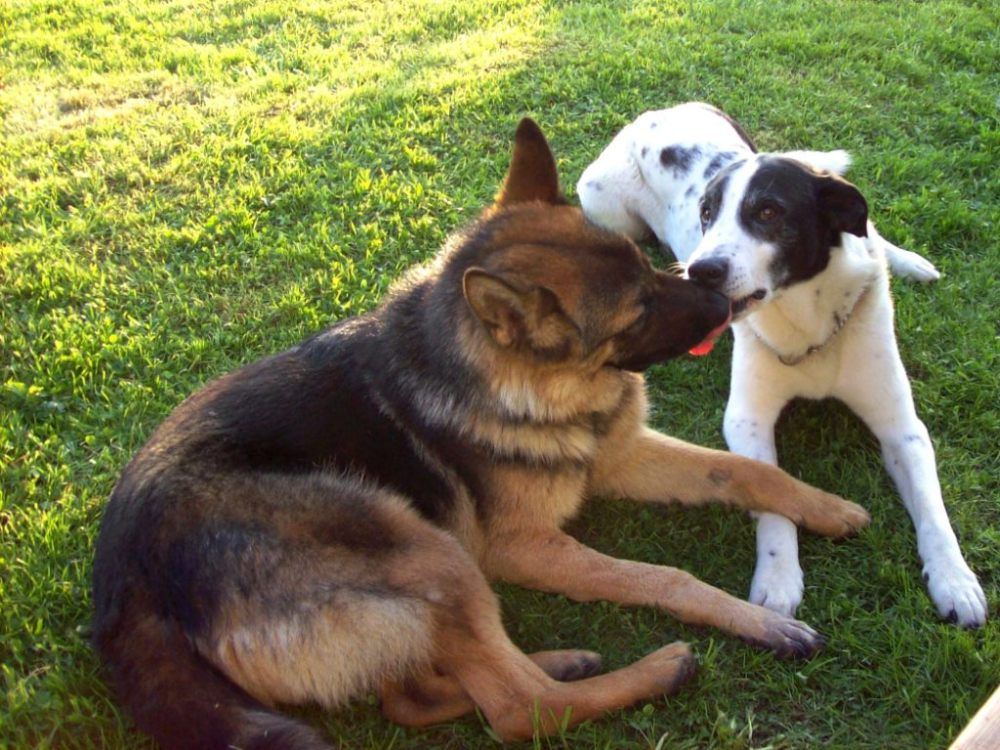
[687,152,868,319]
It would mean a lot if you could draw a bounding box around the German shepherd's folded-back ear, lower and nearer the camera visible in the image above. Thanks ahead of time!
[462,267,564,348]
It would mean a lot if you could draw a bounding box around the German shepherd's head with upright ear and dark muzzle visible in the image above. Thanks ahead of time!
[442,119,729,372]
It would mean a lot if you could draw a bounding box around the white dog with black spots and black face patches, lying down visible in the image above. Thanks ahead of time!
[577,103,987,627]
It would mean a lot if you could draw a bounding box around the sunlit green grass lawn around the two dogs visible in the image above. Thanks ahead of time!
[0,0,1000,750]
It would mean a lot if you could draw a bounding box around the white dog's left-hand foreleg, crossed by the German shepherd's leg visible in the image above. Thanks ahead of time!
[724,400,803,616]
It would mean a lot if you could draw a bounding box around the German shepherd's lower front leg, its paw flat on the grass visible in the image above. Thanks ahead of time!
[484,529,823,657]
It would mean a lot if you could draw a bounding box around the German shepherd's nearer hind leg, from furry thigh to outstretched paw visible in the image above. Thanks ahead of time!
[188,476,692,738]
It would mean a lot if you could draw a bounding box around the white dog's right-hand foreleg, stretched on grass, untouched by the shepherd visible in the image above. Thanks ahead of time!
[878,424,987,628]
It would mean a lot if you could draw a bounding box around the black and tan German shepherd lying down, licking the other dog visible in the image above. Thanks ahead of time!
[93,120,868,750]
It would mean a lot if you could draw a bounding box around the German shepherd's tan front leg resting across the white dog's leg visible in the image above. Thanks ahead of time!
[588,427,871,537]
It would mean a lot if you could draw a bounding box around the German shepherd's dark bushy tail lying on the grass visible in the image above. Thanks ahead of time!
[94,613,332,750]
